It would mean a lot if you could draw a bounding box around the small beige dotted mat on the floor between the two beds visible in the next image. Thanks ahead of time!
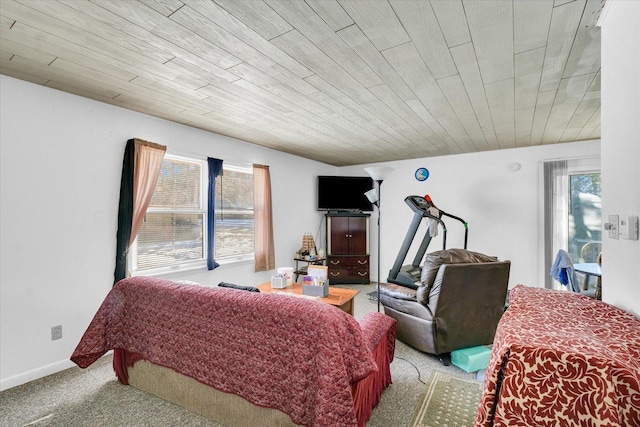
[409,371,483,427]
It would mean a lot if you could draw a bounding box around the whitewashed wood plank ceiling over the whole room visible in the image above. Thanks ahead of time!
[0,0,604,166]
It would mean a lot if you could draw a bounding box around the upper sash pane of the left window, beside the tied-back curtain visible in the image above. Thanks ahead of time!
[149,158,202,209]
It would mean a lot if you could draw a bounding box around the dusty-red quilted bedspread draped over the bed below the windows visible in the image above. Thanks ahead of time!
[71,277,395,427]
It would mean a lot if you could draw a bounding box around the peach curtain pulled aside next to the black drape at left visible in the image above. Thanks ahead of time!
[129,139,167,246]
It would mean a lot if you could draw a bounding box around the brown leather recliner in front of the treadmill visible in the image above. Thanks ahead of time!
[380,249,511,364]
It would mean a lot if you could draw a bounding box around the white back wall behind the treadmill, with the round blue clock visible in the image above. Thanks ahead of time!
[339,140,600,287]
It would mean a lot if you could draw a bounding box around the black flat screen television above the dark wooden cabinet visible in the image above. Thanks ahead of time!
[317,175,373,212]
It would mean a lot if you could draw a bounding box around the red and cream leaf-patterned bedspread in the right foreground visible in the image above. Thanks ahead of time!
[476,285,640,427]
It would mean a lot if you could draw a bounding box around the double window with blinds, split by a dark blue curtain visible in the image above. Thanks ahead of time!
[129,155,253,274]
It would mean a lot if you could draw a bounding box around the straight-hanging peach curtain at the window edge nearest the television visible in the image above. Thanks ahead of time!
[253,165,276,272]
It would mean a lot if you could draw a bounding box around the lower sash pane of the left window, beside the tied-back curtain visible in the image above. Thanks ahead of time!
[136,213,205,269]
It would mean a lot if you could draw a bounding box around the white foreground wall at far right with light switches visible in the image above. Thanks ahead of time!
[601,0,640,316]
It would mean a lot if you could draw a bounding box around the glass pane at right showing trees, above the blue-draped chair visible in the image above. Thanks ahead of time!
[568,173,602,263]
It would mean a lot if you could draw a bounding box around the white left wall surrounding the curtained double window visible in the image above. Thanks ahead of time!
[0,75,336,390]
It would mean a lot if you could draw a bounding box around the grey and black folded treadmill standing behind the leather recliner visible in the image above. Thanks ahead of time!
[387,195,469,289]
